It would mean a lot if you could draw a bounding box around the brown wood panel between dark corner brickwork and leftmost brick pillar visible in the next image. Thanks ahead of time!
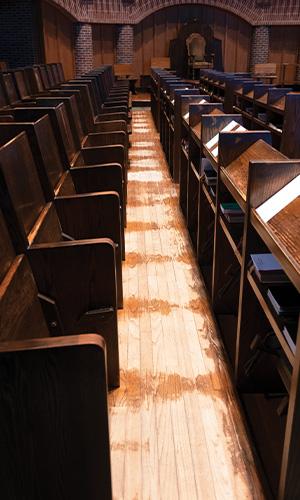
[42,2,75,78]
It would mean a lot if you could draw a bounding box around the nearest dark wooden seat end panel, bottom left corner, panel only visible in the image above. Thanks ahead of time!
[0,334,112,500]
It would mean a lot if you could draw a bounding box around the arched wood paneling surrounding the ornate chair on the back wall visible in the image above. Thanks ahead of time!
[134,4,252,75]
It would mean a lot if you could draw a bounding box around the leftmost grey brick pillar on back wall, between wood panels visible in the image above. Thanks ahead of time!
[73,23,93,76]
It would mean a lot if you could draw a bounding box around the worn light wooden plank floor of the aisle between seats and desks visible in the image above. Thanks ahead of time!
[109,109,263,500]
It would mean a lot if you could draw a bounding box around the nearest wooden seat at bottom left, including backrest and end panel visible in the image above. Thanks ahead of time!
[0,199,112,500]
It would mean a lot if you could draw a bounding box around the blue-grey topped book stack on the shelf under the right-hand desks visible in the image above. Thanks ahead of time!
[250,253,290,283]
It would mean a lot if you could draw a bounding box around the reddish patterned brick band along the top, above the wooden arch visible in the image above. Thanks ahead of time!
[52,0,300,25]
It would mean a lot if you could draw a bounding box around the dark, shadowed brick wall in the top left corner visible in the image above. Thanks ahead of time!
[0,0,42,67]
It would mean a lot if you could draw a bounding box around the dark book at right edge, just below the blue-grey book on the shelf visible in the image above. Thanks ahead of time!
[267,285,300,316]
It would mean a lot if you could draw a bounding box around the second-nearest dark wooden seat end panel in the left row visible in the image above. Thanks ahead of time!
[28,238,120,387]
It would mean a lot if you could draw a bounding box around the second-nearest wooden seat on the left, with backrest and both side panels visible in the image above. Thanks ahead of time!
[0,132,119,387]
